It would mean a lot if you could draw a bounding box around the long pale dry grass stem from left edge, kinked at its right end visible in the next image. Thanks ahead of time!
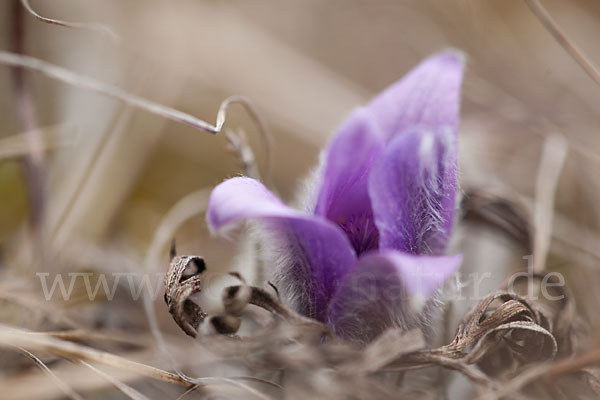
[0,51,246,134]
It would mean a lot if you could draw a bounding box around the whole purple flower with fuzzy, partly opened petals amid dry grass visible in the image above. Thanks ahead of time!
[207,51,463,341]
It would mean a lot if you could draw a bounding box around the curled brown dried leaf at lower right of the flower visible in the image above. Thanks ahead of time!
[383,292,557,376]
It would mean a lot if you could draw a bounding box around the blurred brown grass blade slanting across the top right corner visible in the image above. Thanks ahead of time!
[525,0,600,85]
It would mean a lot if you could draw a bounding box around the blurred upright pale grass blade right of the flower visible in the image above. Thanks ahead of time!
[533,134,568,273]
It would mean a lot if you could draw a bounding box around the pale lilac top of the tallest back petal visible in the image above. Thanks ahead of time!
[369,51,463,140]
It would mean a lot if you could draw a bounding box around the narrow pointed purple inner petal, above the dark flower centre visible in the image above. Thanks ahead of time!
[315,108,383,254]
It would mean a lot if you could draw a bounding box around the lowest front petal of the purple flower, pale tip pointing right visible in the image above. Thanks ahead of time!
[327,251,462,342]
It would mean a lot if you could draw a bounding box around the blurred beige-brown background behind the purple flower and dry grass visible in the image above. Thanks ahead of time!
[0,0,600,399]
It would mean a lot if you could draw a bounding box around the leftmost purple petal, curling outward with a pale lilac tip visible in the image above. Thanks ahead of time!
[207,178,356,321]
